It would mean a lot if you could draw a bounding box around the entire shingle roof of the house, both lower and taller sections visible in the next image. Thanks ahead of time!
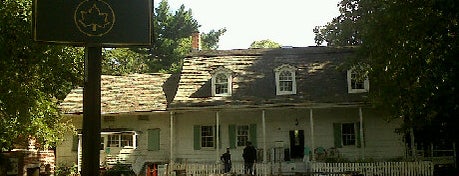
[60,47,367,114]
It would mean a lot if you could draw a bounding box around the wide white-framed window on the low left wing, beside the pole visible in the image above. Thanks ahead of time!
[102,132,136,147]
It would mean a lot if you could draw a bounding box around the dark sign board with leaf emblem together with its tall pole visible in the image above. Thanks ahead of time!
[33,0,152,176]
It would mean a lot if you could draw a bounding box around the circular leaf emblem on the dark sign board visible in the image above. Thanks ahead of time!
[79,4,110,31]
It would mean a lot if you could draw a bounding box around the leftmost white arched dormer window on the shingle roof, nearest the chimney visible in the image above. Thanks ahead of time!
[211,67,233,96]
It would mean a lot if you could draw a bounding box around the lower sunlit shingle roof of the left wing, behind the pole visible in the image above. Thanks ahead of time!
[60,74,175,114]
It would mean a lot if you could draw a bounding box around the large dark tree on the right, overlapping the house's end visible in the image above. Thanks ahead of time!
[314,0,459,162]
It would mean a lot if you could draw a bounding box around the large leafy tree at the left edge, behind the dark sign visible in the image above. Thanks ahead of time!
[0,0,83,151]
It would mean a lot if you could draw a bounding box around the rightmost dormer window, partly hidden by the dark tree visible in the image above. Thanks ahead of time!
[347,69,370,93]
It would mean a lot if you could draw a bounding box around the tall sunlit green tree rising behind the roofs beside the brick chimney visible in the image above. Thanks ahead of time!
[127,0,226,72]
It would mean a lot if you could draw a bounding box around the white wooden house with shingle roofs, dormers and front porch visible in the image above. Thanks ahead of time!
[56,47,406,173]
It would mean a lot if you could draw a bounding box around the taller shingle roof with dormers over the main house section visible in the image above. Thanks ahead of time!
[170,47,367,109]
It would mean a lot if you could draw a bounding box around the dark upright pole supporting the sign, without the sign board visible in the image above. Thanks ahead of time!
[81,47,102,176]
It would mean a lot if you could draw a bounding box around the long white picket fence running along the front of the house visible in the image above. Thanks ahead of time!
[168,161,434,176]
